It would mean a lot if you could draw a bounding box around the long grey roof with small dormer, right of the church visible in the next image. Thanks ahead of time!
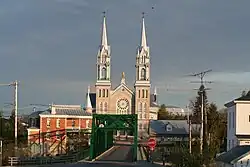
[150,120,200,135]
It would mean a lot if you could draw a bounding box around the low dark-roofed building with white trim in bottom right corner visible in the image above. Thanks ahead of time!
[215,145,250,167]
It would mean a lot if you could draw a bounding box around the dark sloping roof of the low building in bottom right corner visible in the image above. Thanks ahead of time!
[216,145,250,164]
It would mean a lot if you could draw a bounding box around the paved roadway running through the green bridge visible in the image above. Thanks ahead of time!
[98,146,132,162]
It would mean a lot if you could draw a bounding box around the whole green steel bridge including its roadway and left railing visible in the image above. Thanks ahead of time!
[6,114,164,167]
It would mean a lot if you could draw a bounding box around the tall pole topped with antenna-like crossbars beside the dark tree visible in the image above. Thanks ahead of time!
[189,70,213,154]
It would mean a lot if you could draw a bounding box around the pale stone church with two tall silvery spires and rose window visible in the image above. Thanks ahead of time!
[86,15,158,136]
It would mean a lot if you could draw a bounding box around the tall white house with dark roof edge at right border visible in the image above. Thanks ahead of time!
[225,95,250,151]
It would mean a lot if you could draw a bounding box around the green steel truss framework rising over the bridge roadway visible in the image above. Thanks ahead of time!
[90,114,138,161]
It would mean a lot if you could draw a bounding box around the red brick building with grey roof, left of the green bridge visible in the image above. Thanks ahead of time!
[27,89,92,155]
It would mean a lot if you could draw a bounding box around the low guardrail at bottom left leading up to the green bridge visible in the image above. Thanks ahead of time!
[9,149,89,166]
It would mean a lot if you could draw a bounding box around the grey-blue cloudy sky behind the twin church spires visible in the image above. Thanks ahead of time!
[0,0,250,113]
